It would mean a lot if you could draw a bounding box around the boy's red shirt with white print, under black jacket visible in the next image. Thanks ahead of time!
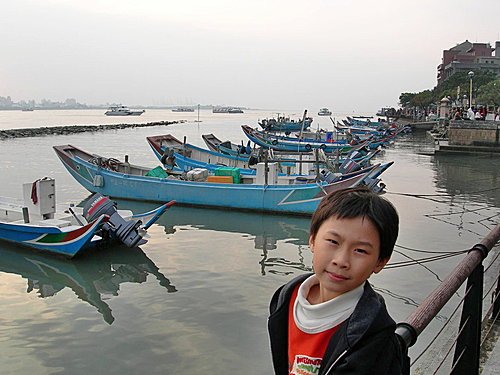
[288,285,339,375]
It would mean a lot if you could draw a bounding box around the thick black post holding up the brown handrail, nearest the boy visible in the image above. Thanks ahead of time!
[450,264,484,375]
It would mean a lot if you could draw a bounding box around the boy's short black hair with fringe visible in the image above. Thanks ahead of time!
[309,186,399,259]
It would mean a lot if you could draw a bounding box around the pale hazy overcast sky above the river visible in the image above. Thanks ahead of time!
[0,0,500,113]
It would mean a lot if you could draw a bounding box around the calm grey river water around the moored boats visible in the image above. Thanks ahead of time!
[0,110,500,375]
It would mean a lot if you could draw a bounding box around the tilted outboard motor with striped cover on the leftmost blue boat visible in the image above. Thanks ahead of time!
[83,193,142,247]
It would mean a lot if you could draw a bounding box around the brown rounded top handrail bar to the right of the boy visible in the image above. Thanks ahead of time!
[396,224,500,348]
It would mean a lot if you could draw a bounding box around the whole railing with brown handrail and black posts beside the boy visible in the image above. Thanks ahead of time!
[396,224,500,375]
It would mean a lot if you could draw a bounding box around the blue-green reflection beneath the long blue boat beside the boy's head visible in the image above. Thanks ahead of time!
[115,199,311,275]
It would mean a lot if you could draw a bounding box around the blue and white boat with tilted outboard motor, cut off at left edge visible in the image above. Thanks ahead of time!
[0,178,173,258]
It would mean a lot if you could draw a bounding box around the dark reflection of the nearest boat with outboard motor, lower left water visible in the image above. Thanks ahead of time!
[0,244,177,324]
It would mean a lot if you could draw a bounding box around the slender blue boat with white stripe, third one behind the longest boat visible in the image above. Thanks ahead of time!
[241,125,356,154]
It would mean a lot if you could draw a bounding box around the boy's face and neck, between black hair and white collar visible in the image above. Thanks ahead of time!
[308,216,389,304]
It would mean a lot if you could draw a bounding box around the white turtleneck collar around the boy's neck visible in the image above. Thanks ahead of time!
[293,275,365,334]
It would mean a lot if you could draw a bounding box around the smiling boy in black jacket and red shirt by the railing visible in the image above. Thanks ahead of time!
[268,187,409,375]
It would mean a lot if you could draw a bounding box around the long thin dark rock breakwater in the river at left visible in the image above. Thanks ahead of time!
[0,121,179,140]
